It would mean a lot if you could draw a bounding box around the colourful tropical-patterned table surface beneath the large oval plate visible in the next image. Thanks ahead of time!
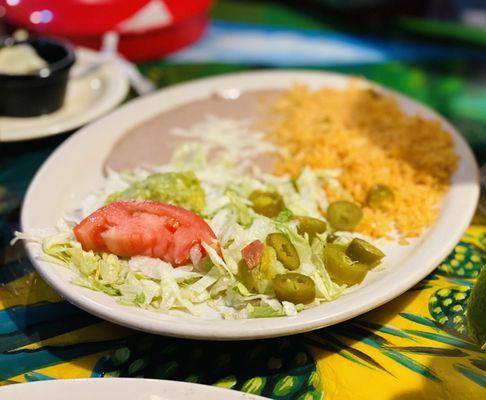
[0,1,486,400]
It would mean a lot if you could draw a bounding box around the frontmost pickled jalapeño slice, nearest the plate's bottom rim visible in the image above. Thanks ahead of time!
[272,272,316,304]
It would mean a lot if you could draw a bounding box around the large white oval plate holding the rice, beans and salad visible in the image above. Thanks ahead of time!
[21,71,479,340]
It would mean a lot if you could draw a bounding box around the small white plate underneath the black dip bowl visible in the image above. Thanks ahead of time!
[0,48,129,142]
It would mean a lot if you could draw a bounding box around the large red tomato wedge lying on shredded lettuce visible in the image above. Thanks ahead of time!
[74,201,216,267]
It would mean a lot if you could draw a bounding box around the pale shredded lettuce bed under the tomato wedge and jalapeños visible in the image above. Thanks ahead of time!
[15,122,384,319]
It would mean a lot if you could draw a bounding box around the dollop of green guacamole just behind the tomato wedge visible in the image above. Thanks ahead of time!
[106,171,206,213]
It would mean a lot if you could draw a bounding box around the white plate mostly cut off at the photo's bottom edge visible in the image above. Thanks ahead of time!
[0,378,265,400]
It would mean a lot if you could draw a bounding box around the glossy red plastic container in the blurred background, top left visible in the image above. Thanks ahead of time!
[0,0,212,61]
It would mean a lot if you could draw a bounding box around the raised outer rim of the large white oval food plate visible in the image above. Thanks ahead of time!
[21,70,479,340]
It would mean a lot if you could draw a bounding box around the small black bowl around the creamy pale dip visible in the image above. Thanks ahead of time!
[0,38,75,117]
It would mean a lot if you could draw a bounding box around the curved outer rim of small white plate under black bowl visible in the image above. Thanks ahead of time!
[0,47,130,143]
